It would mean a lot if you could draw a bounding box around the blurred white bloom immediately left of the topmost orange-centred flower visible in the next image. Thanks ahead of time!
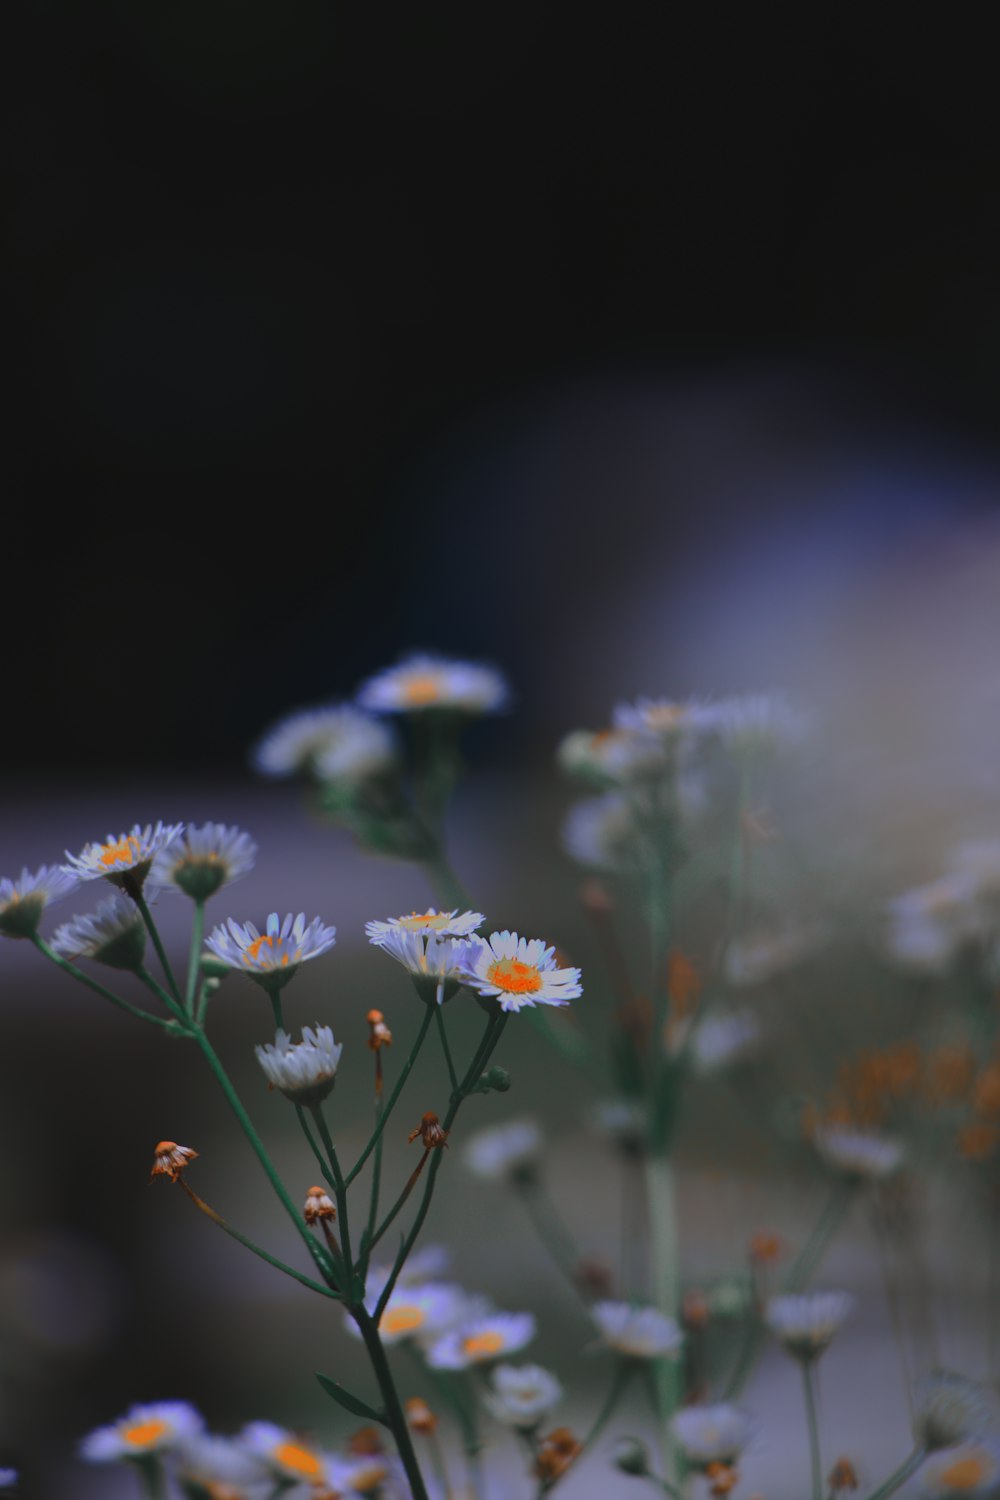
[250,704,396,783]
